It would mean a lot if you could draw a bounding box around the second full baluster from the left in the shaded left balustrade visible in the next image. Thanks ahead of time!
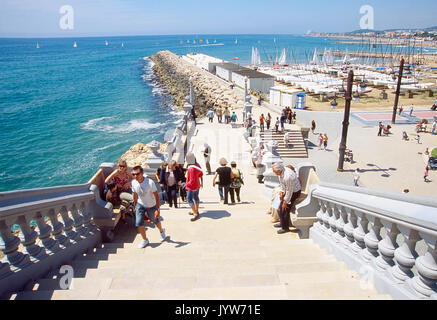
[17,216,47,262]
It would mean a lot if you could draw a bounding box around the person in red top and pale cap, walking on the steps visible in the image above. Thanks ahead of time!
[185,152,203,221]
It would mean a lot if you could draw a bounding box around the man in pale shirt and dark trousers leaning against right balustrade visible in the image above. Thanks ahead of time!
[272,163,302,234]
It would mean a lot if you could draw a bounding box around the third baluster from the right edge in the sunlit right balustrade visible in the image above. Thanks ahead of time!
[375,220,400,271]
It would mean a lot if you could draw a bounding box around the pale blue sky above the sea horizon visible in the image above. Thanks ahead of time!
[0,0,437,37]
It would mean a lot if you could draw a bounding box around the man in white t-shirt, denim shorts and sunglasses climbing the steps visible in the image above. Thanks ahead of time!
[132,166,165,249]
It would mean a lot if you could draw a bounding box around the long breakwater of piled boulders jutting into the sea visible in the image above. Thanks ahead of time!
[150,51,244,116]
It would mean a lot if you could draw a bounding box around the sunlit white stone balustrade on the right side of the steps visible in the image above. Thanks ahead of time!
[304,183,437,299]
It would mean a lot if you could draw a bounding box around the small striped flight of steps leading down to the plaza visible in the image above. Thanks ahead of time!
[261,130,308,158]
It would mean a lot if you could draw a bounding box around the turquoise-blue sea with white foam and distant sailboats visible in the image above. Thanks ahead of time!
[0,35,422,191]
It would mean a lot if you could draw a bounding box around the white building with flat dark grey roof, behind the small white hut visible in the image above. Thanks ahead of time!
[232,68,275,93]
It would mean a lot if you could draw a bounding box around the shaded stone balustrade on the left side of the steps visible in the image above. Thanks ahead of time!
[0,184,101,295]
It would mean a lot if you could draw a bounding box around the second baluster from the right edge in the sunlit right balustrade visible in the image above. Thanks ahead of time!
[391,225,420,284]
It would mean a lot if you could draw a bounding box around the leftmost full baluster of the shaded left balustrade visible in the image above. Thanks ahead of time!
[0,220,30,268]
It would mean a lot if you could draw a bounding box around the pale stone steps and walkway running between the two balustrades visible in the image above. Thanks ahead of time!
[13,120,389,300]
